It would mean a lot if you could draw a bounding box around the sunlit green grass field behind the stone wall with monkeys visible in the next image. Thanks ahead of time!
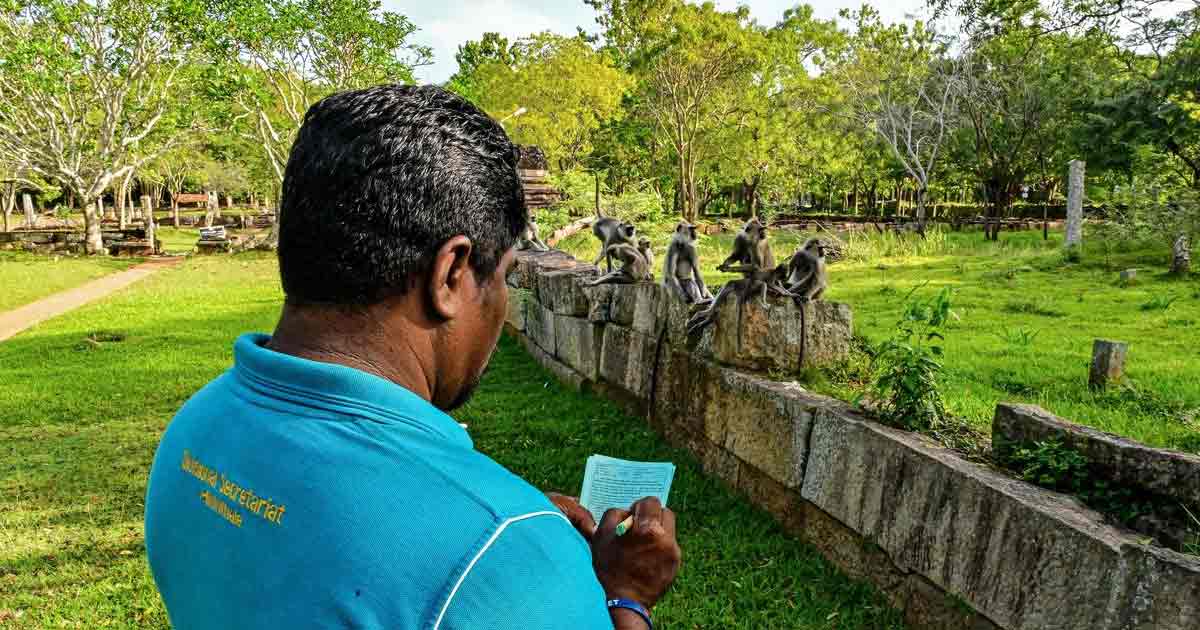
[562,224,1200,452]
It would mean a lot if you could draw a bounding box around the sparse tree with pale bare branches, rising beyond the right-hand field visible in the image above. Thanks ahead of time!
[834,7,961,233]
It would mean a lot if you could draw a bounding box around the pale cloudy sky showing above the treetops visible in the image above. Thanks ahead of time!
[383,0,926,83]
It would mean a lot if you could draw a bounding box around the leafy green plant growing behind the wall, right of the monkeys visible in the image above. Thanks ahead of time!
[871,287,953,431]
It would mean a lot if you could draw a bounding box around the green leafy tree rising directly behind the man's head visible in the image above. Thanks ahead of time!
[199,0,430,245]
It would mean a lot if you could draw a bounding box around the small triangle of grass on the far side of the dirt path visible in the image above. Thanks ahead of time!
[0,251,142,312]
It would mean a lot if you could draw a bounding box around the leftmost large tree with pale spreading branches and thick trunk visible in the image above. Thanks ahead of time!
[0,0,199,253]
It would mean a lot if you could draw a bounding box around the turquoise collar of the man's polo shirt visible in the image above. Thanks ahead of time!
[233,334,474,449]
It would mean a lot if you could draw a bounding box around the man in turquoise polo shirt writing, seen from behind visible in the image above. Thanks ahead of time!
[145,85,679,630]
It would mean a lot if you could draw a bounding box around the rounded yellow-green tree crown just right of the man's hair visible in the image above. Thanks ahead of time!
[470,32,632,170]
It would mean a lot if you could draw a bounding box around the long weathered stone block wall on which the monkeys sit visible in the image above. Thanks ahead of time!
[508,251,1200,630]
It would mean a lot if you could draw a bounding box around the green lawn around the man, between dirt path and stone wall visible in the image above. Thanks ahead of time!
[0,253,901,629]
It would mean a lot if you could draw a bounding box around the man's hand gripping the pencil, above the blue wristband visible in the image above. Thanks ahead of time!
[592,497,683,608]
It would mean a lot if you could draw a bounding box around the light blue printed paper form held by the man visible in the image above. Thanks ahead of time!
[580,455,674,523]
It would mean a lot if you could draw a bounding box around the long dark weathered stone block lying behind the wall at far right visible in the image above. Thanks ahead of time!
[991,403,1200,505]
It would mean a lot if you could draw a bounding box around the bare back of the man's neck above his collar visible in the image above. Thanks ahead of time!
[266,305,434,401]
